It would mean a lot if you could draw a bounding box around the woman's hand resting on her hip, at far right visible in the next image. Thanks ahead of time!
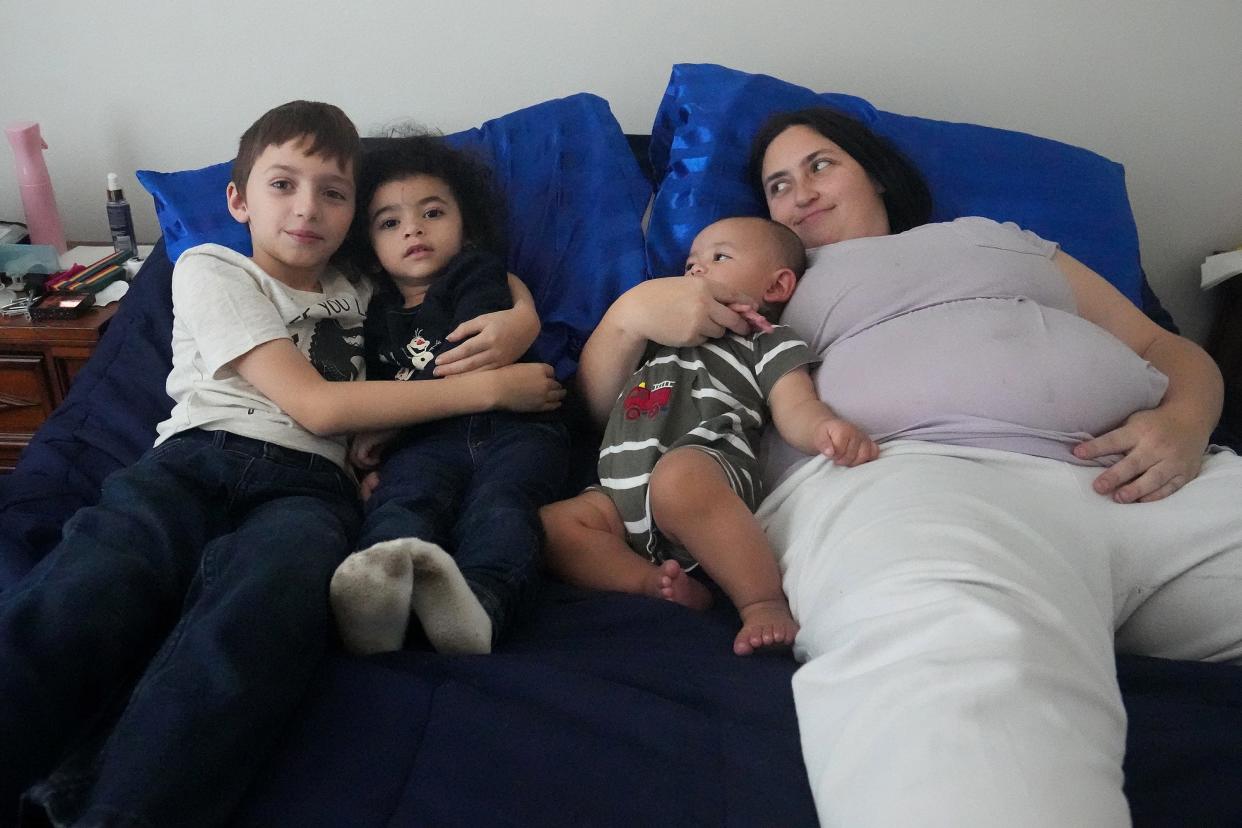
[1074,408,1207,503]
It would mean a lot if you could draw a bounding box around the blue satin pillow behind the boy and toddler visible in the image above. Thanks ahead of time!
[138,93,651,379]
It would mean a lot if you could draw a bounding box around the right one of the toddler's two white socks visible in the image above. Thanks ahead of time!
[392,538,492,654]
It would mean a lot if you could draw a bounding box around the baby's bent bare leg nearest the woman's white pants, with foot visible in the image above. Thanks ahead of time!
[651,448,797,655]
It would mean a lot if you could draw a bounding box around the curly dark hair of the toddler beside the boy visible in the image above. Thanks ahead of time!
[350,133,508,267]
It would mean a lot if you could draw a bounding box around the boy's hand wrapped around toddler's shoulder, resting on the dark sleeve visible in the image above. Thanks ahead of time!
[433,273,540,376]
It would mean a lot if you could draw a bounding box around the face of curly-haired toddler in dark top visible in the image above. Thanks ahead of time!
[366,175,465,289]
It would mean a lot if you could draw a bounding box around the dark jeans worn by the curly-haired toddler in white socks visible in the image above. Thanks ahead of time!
[358,412,569,641]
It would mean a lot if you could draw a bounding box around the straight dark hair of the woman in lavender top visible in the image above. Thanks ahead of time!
[746,107,932,233]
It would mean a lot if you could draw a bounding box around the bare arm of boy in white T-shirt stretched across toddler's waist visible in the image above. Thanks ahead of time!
[232,339,565,436]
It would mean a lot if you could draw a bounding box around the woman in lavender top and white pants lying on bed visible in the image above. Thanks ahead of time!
[580,109,1242,827]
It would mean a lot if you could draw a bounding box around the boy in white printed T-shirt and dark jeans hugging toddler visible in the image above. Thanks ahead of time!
[0,101,563,826]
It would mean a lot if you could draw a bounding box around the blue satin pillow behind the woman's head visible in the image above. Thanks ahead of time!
[647,63,1143,307]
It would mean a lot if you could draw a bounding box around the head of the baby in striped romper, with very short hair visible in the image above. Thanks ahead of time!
[686,218,794,304]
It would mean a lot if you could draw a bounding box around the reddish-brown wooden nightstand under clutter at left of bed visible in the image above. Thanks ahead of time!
[0,303,119,473]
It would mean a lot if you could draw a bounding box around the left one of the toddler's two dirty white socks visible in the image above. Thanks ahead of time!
[329,539,421,655]
